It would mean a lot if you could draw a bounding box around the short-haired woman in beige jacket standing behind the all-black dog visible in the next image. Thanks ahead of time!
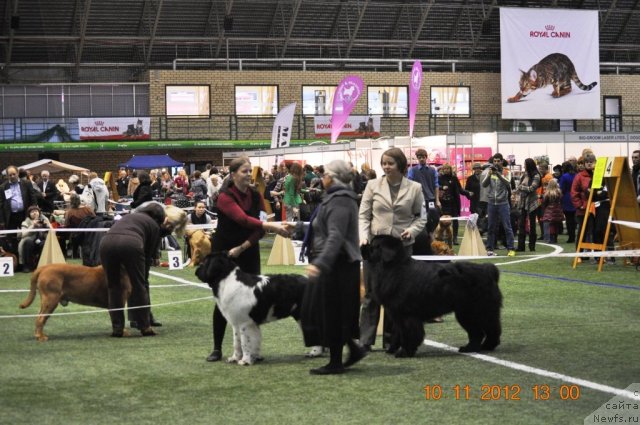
[359,148,427,352]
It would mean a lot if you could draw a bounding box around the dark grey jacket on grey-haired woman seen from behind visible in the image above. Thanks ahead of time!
[311,187,362,273]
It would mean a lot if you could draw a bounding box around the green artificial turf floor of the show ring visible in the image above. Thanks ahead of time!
[0,234,640,424]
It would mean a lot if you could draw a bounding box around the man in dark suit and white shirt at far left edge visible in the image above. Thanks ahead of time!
[0,165,38,254]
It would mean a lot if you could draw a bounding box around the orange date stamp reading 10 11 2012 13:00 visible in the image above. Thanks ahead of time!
[423,384,580,401]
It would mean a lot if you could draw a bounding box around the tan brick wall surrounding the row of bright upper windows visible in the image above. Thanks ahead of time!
[2,70,640,172]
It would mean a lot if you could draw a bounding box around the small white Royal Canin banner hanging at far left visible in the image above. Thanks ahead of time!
[78,117,151,140]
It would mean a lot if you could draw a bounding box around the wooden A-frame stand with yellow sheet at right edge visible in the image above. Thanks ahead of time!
[573,156,640,272]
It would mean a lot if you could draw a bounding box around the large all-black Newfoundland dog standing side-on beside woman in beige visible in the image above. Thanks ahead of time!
[362,236,502,357]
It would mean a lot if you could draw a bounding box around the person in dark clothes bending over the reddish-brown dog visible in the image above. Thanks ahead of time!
[100,202,187,337]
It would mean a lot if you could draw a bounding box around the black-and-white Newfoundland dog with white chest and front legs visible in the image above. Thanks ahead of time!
[196,252,314,365]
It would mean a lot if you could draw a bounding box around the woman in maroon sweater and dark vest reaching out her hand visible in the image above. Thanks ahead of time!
[207,157,293,362]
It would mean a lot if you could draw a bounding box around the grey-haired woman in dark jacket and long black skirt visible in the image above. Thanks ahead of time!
[302,160,366,375]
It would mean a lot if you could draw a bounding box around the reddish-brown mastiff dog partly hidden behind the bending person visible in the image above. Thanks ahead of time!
[20,264,131,341]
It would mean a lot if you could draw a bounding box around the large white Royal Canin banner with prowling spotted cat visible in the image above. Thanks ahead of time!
[500,7,601,120]
